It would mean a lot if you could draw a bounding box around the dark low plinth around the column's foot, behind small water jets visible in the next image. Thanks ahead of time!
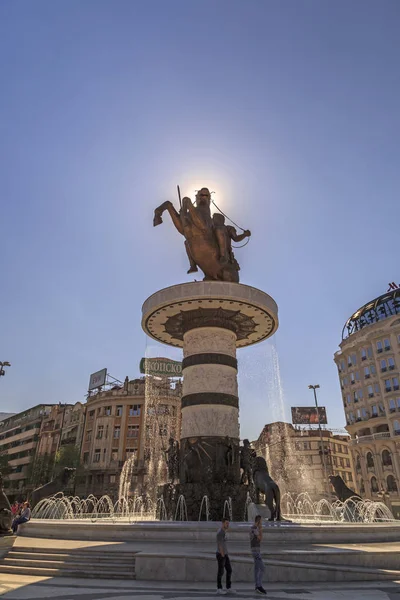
[159,483,248,522]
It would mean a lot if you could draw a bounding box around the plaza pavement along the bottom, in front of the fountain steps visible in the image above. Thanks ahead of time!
[0,574,400,600]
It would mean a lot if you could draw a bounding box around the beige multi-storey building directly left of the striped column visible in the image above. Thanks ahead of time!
[75,376,182,500]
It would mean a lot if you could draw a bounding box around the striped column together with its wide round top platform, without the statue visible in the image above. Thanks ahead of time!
[142,281,278,519]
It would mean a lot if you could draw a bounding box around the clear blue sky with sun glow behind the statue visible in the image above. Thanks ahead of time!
[0,0,400,437]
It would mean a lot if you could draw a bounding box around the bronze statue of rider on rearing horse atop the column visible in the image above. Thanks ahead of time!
[153,188,251,283]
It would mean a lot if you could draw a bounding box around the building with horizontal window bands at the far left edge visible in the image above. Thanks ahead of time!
[0,404,53,501]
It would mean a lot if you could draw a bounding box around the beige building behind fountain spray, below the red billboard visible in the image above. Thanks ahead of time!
[252,422,354,500]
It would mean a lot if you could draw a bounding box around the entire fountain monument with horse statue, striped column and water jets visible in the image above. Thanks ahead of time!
[21,189,400,581]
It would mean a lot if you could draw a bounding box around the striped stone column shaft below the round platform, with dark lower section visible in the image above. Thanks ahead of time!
[181,326,239,483]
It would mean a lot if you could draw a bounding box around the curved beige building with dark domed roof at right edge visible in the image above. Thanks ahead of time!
[335,289,400,517]
